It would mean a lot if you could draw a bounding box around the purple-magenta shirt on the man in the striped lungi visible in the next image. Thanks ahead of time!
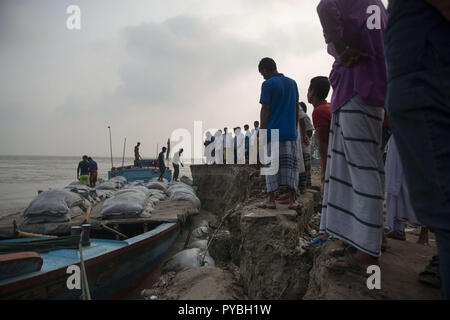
[317,0,387,112]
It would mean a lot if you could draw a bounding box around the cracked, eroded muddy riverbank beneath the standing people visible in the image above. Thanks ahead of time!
[124,166,440,300]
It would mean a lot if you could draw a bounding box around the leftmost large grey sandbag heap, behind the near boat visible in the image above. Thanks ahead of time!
[22,189,86,225]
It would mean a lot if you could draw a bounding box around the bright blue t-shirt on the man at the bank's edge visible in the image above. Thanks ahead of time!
[259,73,299,141]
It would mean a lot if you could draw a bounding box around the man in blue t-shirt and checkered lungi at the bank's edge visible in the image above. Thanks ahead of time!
[258,58,300,210]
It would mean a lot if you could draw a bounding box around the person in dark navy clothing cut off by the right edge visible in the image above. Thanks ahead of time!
[386,0,450,299]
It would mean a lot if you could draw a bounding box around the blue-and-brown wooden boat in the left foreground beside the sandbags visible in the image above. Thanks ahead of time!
[0,222,180,300]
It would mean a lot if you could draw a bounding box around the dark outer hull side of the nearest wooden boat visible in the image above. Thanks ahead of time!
[0,223,180,300]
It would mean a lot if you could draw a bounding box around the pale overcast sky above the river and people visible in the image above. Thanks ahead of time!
[0,0,386,157]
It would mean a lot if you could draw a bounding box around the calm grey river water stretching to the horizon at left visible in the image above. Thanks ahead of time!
[0,156,190,216]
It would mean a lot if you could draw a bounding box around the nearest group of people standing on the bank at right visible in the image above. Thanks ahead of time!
[259,0,450,299]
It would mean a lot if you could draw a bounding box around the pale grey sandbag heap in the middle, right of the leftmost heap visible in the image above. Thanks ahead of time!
[100,188,153,219]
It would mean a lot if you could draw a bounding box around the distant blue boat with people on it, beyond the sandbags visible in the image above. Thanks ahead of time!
[108,159,172,182]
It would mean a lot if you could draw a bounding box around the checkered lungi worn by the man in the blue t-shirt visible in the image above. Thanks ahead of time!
[266,141,299,192]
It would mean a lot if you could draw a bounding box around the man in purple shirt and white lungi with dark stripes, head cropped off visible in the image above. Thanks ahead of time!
[317,0,387,275]
